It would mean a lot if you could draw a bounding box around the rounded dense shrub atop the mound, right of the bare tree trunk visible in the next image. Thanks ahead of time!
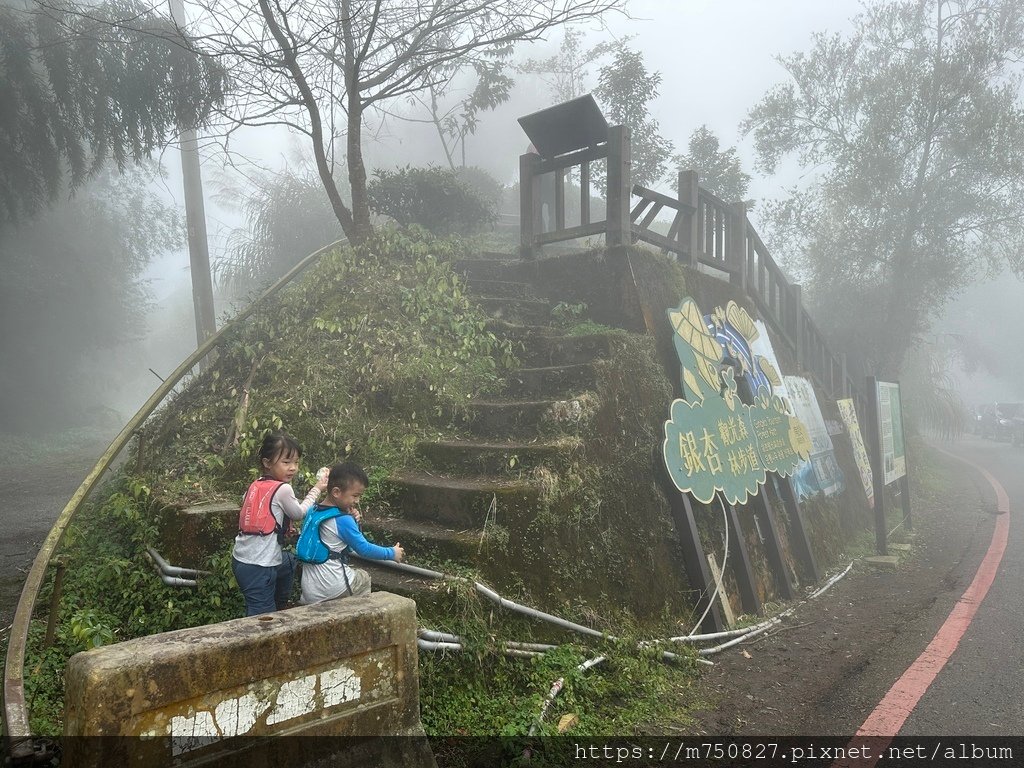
[369,167,498,236]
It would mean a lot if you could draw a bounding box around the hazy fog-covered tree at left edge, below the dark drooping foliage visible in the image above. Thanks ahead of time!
[0,166,184,431]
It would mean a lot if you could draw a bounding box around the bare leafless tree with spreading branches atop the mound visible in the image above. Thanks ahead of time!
[193,0,625,242]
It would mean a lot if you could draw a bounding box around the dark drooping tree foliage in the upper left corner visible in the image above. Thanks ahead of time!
[0,0,224,226]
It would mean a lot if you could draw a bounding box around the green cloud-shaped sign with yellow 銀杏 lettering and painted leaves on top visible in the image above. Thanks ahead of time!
[663,297,811,504]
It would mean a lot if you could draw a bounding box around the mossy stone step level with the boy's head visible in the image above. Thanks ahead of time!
[388,471,541,529]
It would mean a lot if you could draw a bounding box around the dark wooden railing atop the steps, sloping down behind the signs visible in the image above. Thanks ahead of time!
[519,126,865,414]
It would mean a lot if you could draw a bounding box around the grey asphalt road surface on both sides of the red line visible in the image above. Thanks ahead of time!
[812,436,1024,736]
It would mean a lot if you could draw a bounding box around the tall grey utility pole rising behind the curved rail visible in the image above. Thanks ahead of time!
[169,0,217,369]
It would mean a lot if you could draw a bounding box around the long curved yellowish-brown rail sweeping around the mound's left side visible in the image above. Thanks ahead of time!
[3,238,348,759]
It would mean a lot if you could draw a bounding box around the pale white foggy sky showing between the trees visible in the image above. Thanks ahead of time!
[5,0,1024,434]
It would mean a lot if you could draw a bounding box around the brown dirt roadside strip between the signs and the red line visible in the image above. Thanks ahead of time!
[691,444,994,736]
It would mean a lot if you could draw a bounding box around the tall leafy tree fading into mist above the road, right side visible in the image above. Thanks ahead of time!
[744,0,1024,375]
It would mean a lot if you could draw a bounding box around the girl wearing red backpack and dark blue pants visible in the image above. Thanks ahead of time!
[231,432,327,616]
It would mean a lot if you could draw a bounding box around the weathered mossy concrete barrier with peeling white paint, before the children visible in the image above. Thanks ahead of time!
[62,593,434,766]
